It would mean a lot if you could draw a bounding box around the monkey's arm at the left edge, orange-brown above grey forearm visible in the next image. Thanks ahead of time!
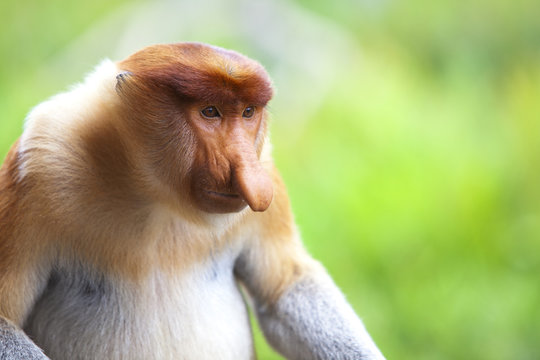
[0,140,47,360]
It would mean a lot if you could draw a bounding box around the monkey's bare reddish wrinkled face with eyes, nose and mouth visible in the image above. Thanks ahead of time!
[188,103,273,213]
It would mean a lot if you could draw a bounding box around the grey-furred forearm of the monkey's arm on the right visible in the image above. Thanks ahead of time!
[257,274,384,360]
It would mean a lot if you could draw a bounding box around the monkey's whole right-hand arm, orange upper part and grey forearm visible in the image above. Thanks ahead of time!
[236,169,384,360]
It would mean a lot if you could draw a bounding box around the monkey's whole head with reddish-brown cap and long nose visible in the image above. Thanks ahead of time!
[116,43,273,213]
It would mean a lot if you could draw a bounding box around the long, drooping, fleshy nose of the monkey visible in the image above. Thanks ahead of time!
[228,134,274,211]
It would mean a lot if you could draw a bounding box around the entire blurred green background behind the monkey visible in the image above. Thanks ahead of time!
[0,0,540,360]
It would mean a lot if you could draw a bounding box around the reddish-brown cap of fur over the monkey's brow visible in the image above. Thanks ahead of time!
[118,43,273,105]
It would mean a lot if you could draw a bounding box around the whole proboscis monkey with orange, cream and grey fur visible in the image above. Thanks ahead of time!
[0,43,383,360]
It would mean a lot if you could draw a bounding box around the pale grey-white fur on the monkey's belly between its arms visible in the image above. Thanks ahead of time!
[25,248,254,359]
